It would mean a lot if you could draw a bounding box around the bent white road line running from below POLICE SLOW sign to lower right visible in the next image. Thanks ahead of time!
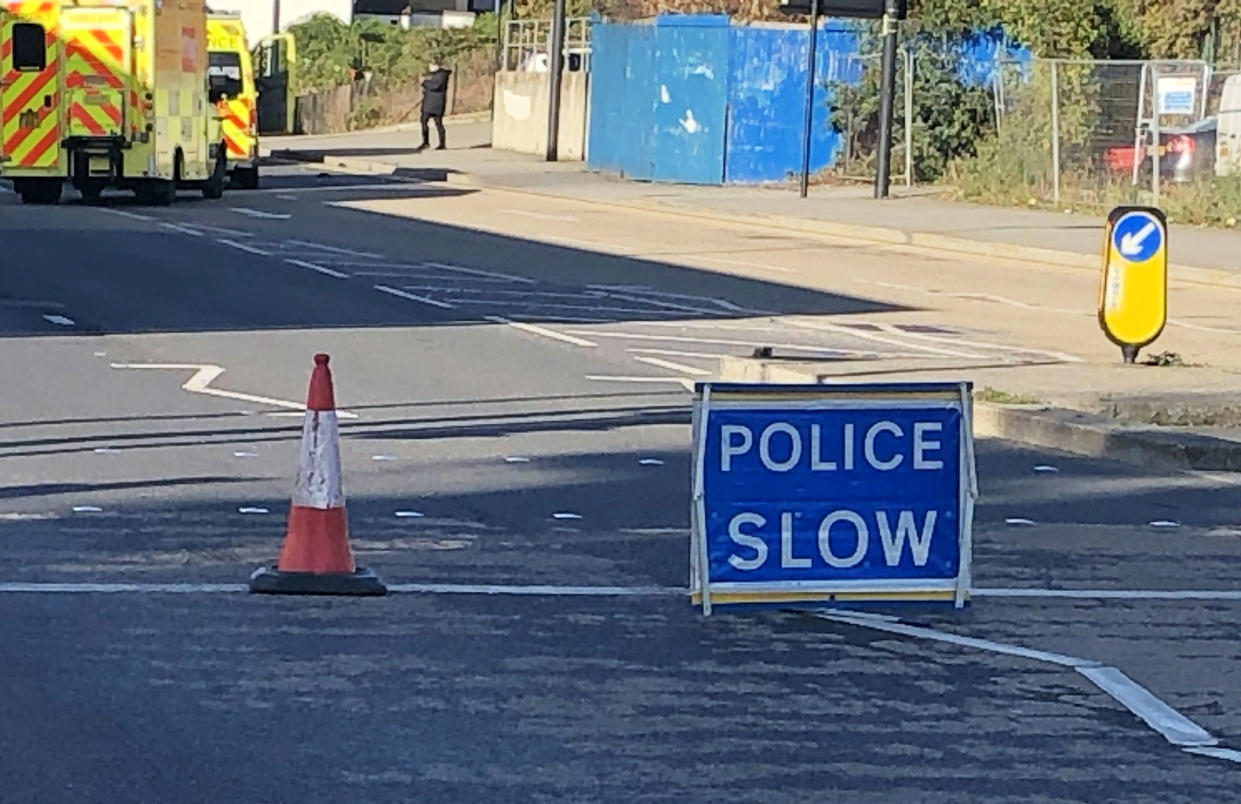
[815,612,1219,748]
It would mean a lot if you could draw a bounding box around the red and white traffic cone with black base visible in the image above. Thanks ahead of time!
[249,355,387,594]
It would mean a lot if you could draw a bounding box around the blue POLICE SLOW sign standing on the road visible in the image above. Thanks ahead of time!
[691,383,975,613]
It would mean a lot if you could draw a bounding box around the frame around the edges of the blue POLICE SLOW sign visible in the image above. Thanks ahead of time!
[690,382,978,615]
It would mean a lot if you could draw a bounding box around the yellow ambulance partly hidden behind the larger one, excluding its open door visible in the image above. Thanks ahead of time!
[207,11,258,190]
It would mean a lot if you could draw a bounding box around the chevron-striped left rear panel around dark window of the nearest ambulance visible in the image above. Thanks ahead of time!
[0,2,61,169]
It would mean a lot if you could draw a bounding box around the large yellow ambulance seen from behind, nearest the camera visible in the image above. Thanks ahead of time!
[0,0,227,206]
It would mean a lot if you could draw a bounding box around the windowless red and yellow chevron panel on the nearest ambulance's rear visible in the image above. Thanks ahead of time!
[65,29,124,136]
